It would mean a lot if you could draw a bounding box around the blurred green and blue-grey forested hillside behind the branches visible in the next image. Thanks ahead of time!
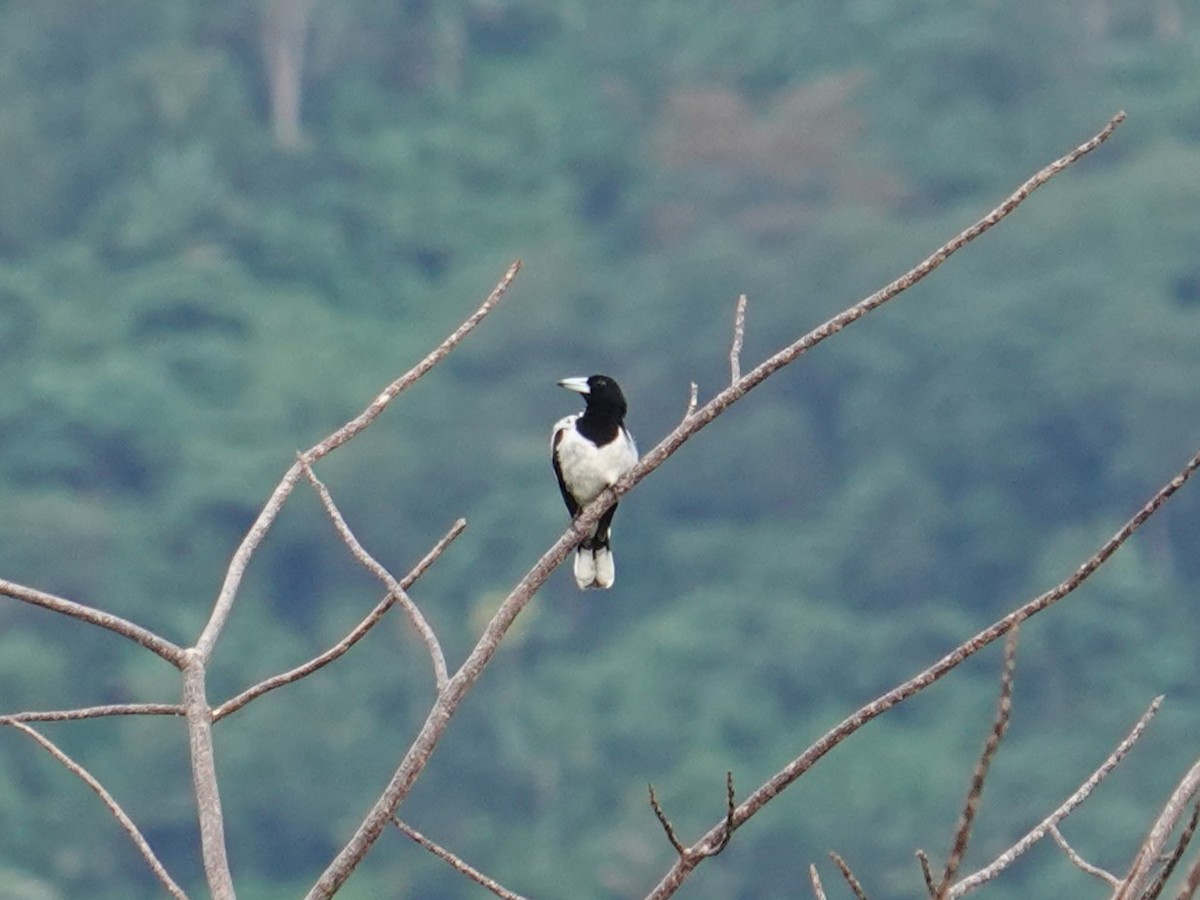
[0,0,1200,900]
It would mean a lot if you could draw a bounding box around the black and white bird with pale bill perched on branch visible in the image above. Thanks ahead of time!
[551,376,637,590]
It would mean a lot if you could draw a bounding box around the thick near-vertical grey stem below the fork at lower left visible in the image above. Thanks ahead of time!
[184,649,235,900]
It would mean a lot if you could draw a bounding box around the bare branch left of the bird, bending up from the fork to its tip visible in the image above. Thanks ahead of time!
[196,259,521,661]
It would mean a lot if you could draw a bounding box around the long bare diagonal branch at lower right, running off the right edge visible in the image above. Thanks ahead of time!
[648,432,1200,900]
